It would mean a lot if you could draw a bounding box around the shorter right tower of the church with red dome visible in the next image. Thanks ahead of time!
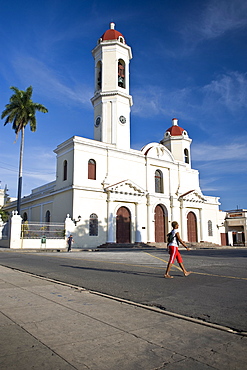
[160,118,192,168]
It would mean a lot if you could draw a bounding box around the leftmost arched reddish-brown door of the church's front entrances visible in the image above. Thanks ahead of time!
[116,207,131,243]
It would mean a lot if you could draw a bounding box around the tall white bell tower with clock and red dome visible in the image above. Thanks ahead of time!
[91,23,133,150]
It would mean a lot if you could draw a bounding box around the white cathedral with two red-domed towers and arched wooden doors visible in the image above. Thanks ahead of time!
[2,23,226,248]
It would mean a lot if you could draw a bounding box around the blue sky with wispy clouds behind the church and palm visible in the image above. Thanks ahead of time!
[0,0,247,210]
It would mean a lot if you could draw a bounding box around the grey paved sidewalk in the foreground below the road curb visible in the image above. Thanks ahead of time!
[0,266,247,370]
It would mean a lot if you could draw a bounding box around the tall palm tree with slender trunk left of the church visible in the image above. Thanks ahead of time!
[1,86,48,215]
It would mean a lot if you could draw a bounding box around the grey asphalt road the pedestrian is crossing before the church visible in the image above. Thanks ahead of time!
[0,248,247,332]
